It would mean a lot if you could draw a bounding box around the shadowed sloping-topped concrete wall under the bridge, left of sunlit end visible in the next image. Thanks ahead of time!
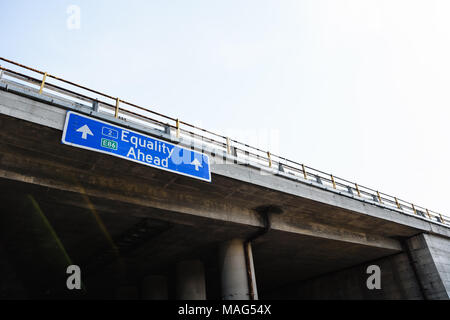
[269,253,423,300]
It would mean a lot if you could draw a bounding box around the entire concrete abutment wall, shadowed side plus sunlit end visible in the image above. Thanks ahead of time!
[271,234,450,300]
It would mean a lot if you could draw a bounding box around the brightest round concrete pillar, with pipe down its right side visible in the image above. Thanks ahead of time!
[219,239,258,300]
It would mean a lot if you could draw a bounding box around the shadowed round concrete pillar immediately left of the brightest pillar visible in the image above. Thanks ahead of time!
[176,260,206,300]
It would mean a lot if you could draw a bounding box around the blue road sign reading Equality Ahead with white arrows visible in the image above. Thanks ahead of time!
[62,111,211,182]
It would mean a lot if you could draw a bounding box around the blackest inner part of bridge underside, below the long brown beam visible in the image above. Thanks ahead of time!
[0,179,395,298]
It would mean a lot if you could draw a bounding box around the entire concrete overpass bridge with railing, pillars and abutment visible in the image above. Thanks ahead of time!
[0,58,450,299]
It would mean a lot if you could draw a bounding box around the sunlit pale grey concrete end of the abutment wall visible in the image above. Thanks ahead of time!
[407,234,450,299]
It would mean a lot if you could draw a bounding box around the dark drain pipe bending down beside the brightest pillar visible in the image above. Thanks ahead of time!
[244,205,283,300]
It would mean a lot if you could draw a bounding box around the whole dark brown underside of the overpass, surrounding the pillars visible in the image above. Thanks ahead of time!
[0,106,448,299]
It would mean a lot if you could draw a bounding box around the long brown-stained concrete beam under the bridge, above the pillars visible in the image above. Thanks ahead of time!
[0,165,401,251]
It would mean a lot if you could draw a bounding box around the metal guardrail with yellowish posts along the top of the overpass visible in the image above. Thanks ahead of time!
[0,57,450,225]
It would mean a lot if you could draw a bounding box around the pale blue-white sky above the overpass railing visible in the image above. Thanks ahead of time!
[0,0,450,215]
